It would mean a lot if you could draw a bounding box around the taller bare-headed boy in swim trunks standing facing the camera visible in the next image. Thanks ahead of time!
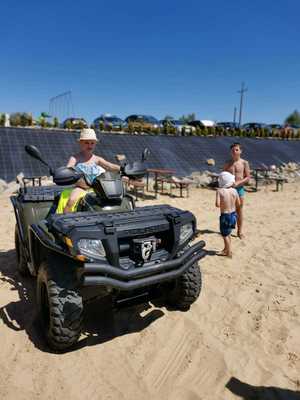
[223,143,250,239]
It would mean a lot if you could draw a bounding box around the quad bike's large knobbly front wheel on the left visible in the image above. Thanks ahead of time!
[37,258,83,351]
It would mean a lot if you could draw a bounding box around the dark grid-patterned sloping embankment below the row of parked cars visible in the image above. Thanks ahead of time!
[0,128,300,182]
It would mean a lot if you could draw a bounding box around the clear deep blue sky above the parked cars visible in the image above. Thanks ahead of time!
[0,0,300,122]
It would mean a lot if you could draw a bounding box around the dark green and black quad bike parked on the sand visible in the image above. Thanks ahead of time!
[11,145,205,351]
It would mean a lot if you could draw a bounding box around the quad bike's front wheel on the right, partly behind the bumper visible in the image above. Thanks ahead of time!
[167,263,202,311]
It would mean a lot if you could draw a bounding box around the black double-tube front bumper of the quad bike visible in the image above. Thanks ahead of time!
[82,241,205,291]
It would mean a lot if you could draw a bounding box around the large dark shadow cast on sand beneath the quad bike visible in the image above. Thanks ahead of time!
[0,250,164,353]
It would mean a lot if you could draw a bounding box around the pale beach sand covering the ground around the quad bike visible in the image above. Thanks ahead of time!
[0,184,300,400]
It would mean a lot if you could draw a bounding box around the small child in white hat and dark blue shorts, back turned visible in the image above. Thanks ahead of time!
[216,171,240,258]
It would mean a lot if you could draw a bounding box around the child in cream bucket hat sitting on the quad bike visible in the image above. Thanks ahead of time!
[62,129,120,213]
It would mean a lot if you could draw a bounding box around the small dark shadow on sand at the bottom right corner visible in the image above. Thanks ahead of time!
[226,377,300,400]
